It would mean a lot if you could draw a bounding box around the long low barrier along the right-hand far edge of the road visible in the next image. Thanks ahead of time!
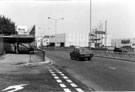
[92,50,135,62]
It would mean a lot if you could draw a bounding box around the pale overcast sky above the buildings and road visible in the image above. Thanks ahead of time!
[0,0,135,38]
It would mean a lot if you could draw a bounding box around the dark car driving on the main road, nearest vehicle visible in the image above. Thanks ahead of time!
[70,47,93,60]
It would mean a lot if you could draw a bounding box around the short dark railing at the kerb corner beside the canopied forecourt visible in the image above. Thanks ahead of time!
[30,49,45,63]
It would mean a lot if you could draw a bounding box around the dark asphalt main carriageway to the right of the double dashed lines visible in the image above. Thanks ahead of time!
[46,51,135,91]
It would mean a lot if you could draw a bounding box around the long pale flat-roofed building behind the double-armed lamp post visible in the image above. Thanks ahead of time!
[49,33,89,47]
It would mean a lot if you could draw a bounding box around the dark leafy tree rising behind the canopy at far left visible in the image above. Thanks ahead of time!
[0,16,17,35]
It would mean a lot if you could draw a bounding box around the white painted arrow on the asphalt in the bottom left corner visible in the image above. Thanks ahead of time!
[2,84,28,92]
